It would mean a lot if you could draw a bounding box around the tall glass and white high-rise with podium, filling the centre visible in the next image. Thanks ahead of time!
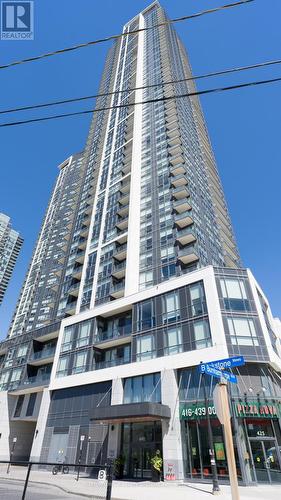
[0,2,281,484]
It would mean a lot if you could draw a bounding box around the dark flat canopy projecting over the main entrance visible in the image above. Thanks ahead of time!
[90,402,171,424]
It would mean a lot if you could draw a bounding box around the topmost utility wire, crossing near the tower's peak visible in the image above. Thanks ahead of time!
[0,0,255,69]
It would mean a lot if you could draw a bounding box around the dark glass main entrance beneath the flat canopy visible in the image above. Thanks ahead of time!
[121,422,162,480]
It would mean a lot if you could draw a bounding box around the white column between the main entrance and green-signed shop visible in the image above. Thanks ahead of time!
[161,370,184,480]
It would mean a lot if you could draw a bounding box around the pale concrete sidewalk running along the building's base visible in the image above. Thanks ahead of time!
[0,466,281,500]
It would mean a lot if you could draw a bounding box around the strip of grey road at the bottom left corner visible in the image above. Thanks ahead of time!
[0,479,85,500]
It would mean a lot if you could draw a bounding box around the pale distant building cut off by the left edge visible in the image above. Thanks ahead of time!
[0,213,23,304]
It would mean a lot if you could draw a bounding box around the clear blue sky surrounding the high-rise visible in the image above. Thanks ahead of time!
[0,0,281,338]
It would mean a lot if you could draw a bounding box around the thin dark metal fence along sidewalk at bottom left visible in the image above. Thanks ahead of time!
[0,460,113,500]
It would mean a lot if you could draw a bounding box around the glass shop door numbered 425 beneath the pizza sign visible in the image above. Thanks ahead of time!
[250,439,281,483]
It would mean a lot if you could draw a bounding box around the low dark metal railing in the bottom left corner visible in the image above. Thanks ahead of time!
[0,460,113,500]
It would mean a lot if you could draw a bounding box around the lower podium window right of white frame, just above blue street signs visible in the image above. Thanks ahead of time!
[227,317,259,346]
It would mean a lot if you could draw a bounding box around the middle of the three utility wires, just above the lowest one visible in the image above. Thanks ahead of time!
[0,59,281,115]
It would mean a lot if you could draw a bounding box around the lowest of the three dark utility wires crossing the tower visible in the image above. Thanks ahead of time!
[0,77,281,127]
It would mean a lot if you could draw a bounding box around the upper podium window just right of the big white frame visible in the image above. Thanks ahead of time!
[220,278,250,311]
